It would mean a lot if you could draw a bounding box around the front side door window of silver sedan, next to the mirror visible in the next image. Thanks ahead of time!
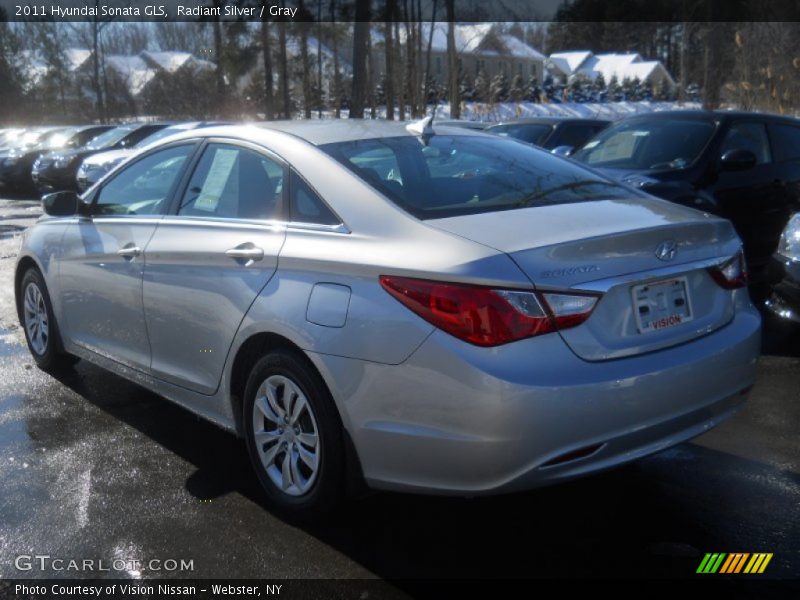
[94,144,193,215]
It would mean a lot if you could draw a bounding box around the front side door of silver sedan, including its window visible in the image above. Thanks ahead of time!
[59,144,194,371]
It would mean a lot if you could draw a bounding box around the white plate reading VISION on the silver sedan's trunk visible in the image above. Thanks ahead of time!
[631,277,694,333]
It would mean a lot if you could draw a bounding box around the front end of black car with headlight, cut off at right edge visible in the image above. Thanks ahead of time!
[765,213,800,324]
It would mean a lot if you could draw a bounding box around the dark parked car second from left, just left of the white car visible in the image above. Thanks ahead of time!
[31,123,169,192]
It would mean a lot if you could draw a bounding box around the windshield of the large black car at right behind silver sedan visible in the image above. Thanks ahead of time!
[572,117,716,170]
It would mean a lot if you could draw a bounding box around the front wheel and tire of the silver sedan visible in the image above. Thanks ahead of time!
[18,268,78,371]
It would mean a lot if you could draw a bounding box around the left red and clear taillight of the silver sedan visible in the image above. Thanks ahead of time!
[380,275,599,346]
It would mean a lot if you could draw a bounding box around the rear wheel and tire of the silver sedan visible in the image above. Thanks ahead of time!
[242,349,344,519]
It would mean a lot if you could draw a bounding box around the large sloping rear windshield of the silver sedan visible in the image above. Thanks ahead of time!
[320,135,637,219]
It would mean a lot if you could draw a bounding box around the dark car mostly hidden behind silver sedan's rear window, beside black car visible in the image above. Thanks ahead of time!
[486,117,611,151]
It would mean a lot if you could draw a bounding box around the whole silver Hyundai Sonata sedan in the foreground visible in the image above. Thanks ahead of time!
[16,121,760,513]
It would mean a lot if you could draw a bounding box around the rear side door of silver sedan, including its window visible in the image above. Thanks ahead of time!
[143,140,286,394]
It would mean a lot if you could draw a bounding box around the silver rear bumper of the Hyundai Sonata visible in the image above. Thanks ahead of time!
[312,292,761,495]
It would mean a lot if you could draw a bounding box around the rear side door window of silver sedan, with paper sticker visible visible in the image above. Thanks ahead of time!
[178,144,283,219]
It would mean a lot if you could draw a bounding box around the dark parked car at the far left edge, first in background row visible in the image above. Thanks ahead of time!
[0,125,111,192]
